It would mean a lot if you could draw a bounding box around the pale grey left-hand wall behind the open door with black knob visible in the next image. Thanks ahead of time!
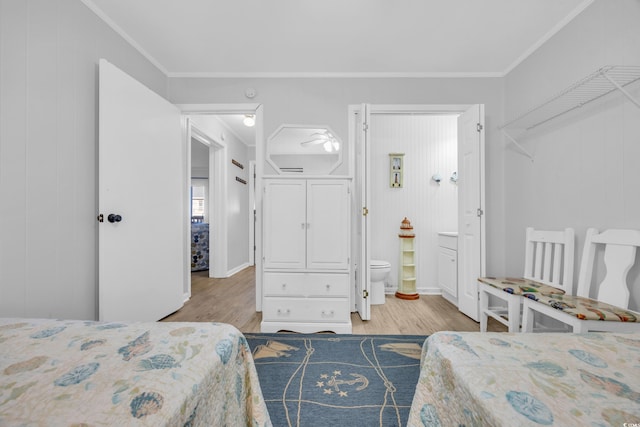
[0,0,166,319]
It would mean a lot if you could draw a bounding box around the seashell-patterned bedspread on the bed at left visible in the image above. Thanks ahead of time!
[0,319,271,426]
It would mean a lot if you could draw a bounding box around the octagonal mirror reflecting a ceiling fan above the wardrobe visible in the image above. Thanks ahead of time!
[267,125,343,175]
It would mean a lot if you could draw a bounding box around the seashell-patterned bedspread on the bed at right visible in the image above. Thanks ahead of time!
[409,332,640,427]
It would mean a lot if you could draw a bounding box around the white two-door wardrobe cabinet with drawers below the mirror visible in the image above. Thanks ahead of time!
[261,178,351,333]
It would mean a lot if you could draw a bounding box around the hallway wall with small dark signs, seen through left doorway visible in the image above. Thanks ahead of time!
[190,115,253,272]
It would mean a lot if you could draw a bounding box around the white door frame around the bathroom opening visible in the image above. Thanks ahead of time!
[349,104,486,316]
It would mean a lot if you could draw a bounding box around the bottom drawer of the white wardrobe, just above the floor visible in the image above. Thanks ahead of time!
[262,297,351,322]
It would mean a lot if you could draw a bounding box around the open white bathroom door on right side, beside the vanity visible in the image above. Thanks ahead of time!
[458,105,485,321]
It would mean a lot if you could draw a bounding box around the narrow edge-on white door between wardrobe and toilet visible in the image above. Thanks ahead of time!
[355,104,371,320]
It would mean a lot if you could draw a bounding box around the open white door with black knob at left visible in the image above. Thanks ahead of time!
[98,60,187,321]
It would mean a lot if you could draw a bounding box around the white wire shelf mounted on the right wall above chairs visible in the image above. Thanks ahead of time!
[499,65,640,160]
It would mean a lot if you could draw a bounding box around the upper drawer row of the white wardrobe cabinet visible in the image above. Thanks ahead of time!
[263,273,349,298]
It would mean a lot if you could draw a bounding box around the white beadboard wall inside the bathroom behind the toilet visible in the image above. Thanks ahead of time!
[369,114,458,294]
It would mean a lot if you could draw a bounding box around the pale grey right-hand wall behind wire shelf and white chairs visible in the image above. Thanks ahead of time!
[504,0,640,310]
